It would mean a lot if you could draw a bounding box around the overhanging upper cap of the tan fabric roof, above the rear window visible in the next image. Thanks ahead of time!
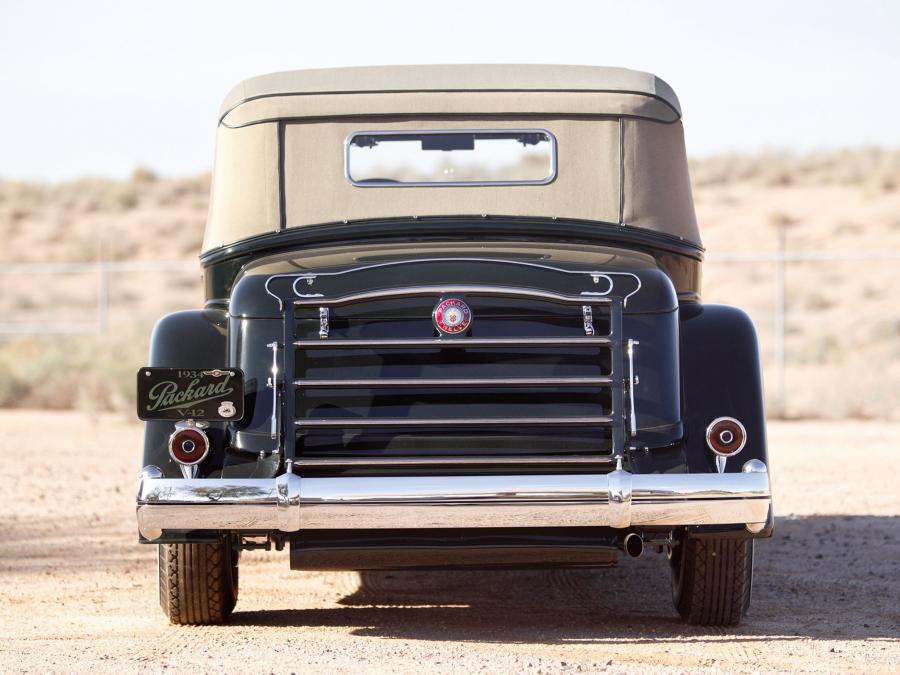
[219,65,681,126]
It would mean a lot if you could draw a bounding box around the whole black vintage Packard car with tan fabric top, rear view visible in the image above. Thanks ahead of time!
[137,66,773,625]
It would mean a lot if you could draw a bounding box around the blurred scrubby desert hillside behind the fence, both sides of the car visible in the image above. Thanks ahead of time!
[0,148,900,420]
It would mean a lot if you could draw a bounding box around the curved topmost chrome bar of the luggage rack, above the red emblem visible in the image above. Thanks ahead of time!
[293,284,612,307]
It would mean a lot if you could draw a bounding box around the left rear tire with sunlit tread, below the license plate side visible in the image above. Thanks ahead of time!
[159,539,238,624]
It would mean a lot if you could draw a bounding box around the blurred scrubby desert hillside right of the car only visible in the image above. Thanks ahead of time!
[692,149,900,420]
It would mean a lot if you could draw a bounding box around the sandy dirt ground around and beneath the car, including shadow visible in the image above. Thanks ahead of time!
[0,410,900,673]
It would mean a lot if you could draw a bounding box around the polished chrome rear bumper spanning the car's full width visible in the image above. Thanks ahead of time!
[137,460,771,540]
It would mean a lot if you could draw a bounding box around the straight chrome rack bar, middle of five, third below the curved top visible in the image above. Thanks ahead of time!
[294,377,612,389]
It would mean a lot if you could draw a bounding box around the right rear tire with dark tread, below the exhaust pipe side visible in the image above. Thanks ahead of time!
[671,538,753,626]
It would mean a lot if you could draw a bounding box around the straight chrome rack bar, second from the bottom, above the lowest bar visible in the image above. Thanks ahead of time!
[294,415,613,429]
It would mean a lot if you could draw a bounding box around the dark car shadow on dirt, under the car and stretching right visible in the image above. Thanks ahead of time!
[232,515,900,644]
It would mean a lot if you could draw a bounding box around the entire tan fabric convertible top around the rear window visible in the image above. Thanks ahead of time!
[203,65,700,251]
